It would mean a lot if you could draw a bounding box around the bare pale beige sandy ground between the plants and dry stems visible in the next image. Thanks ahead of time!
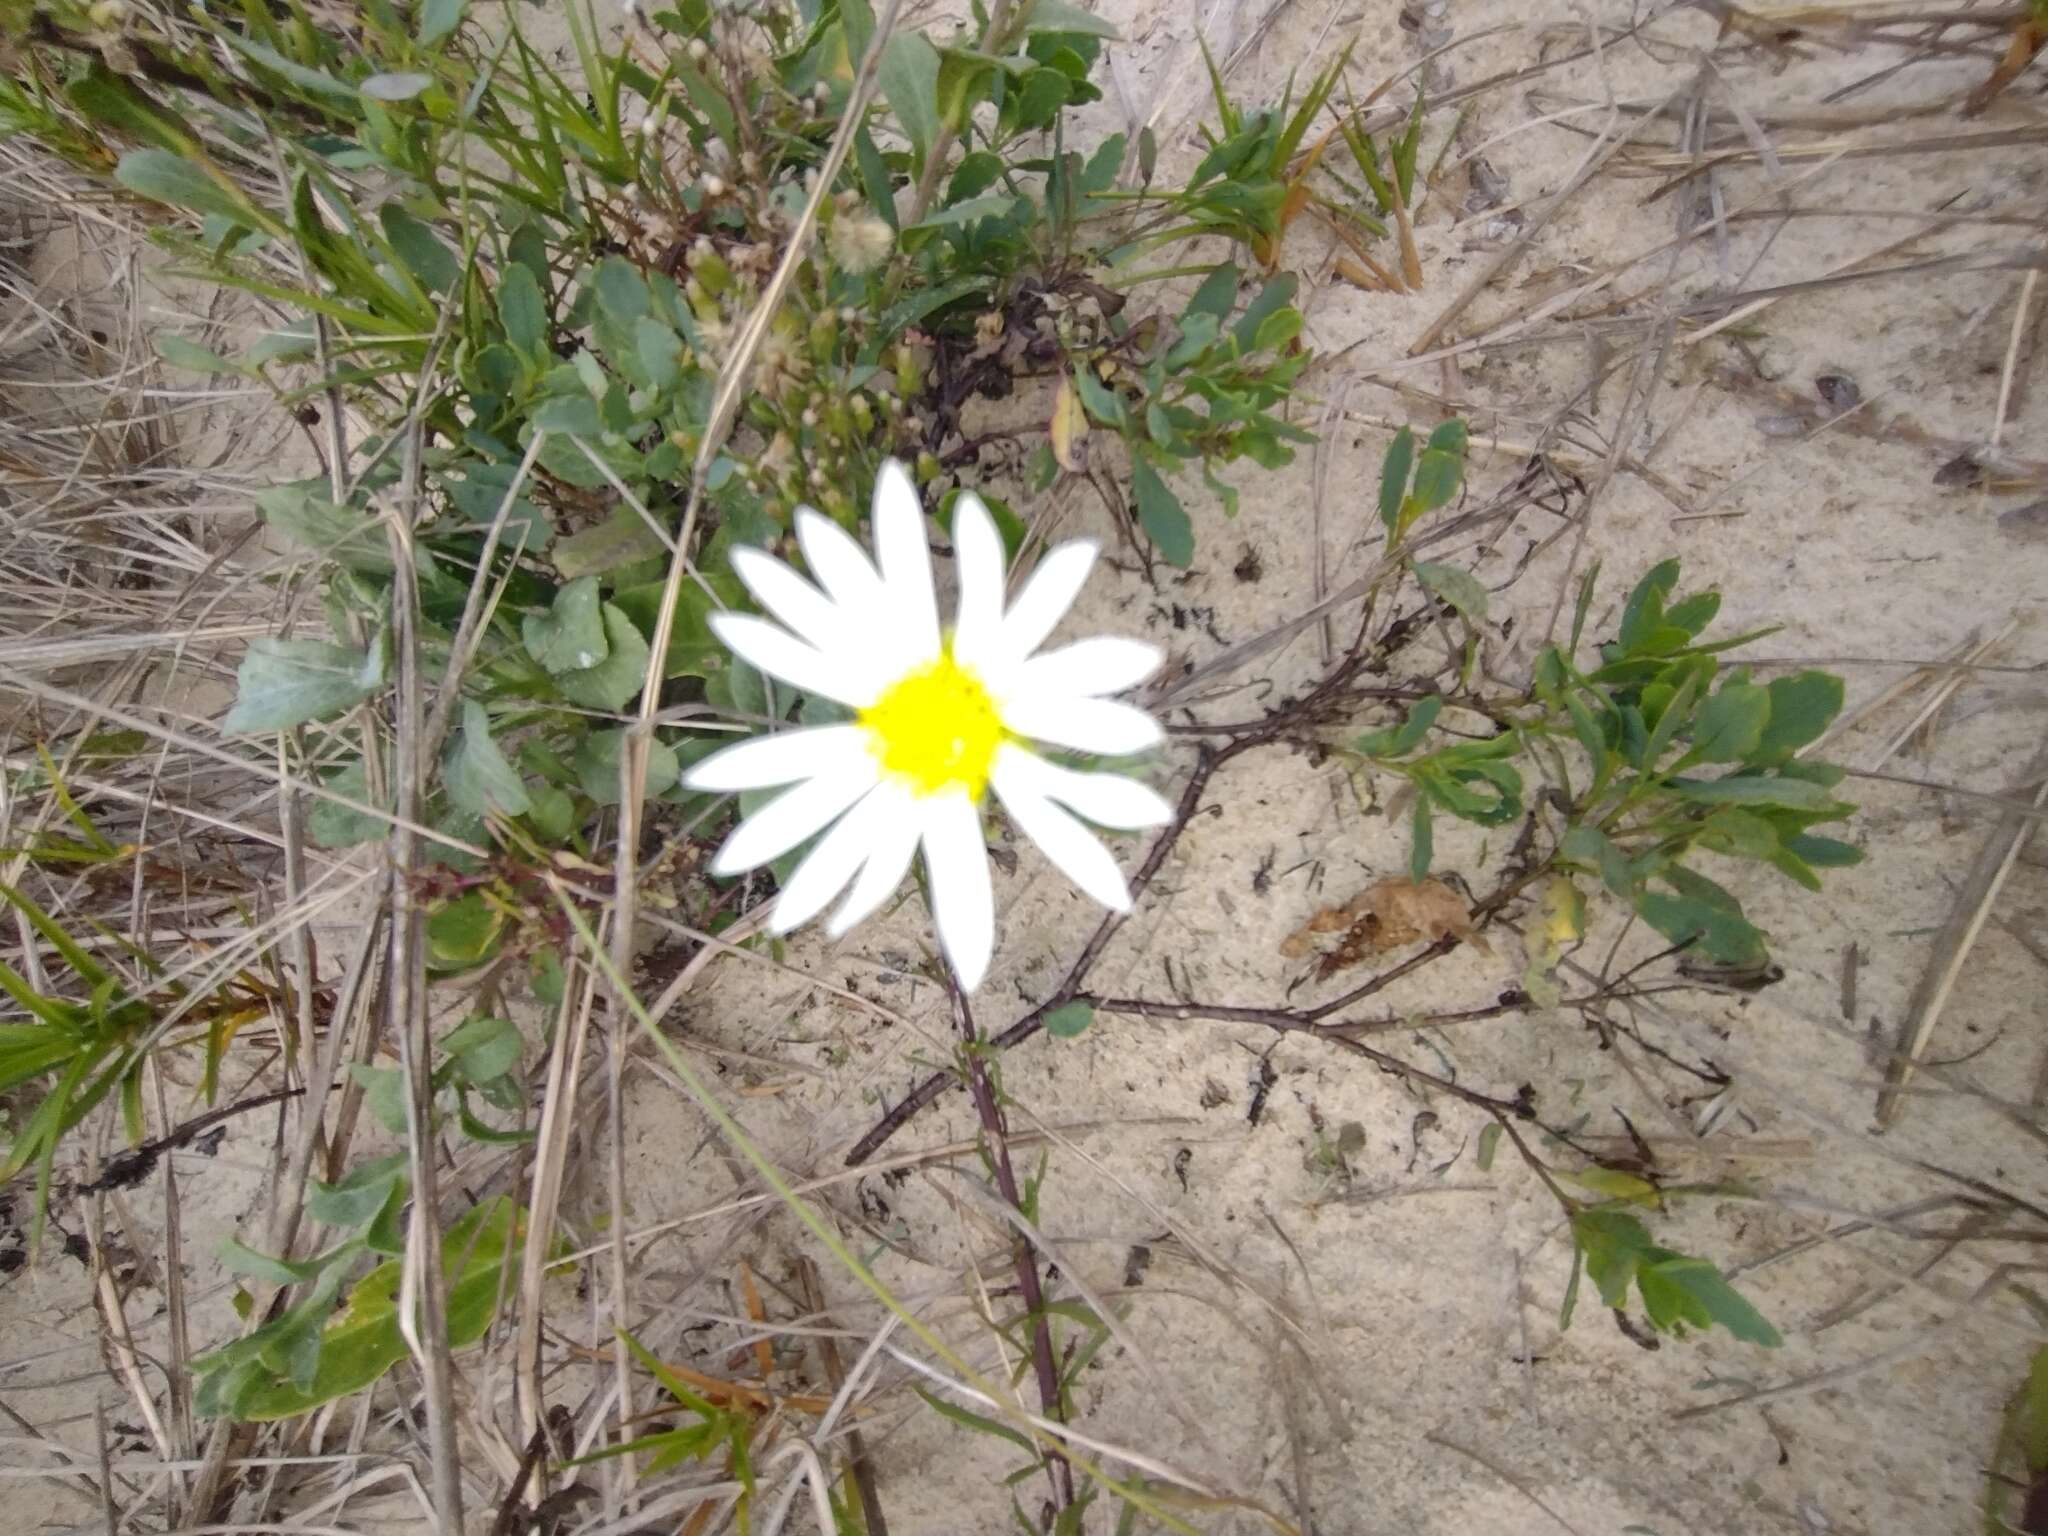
[0,0,2048,1536]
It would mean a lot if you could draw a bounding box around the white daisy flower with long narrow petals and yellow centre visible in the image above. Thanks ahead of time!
[688,459,1174,991]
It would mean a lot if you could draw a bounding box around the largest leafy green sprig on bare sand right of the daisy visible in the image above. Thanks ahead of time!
[1352,422,1862,977]
